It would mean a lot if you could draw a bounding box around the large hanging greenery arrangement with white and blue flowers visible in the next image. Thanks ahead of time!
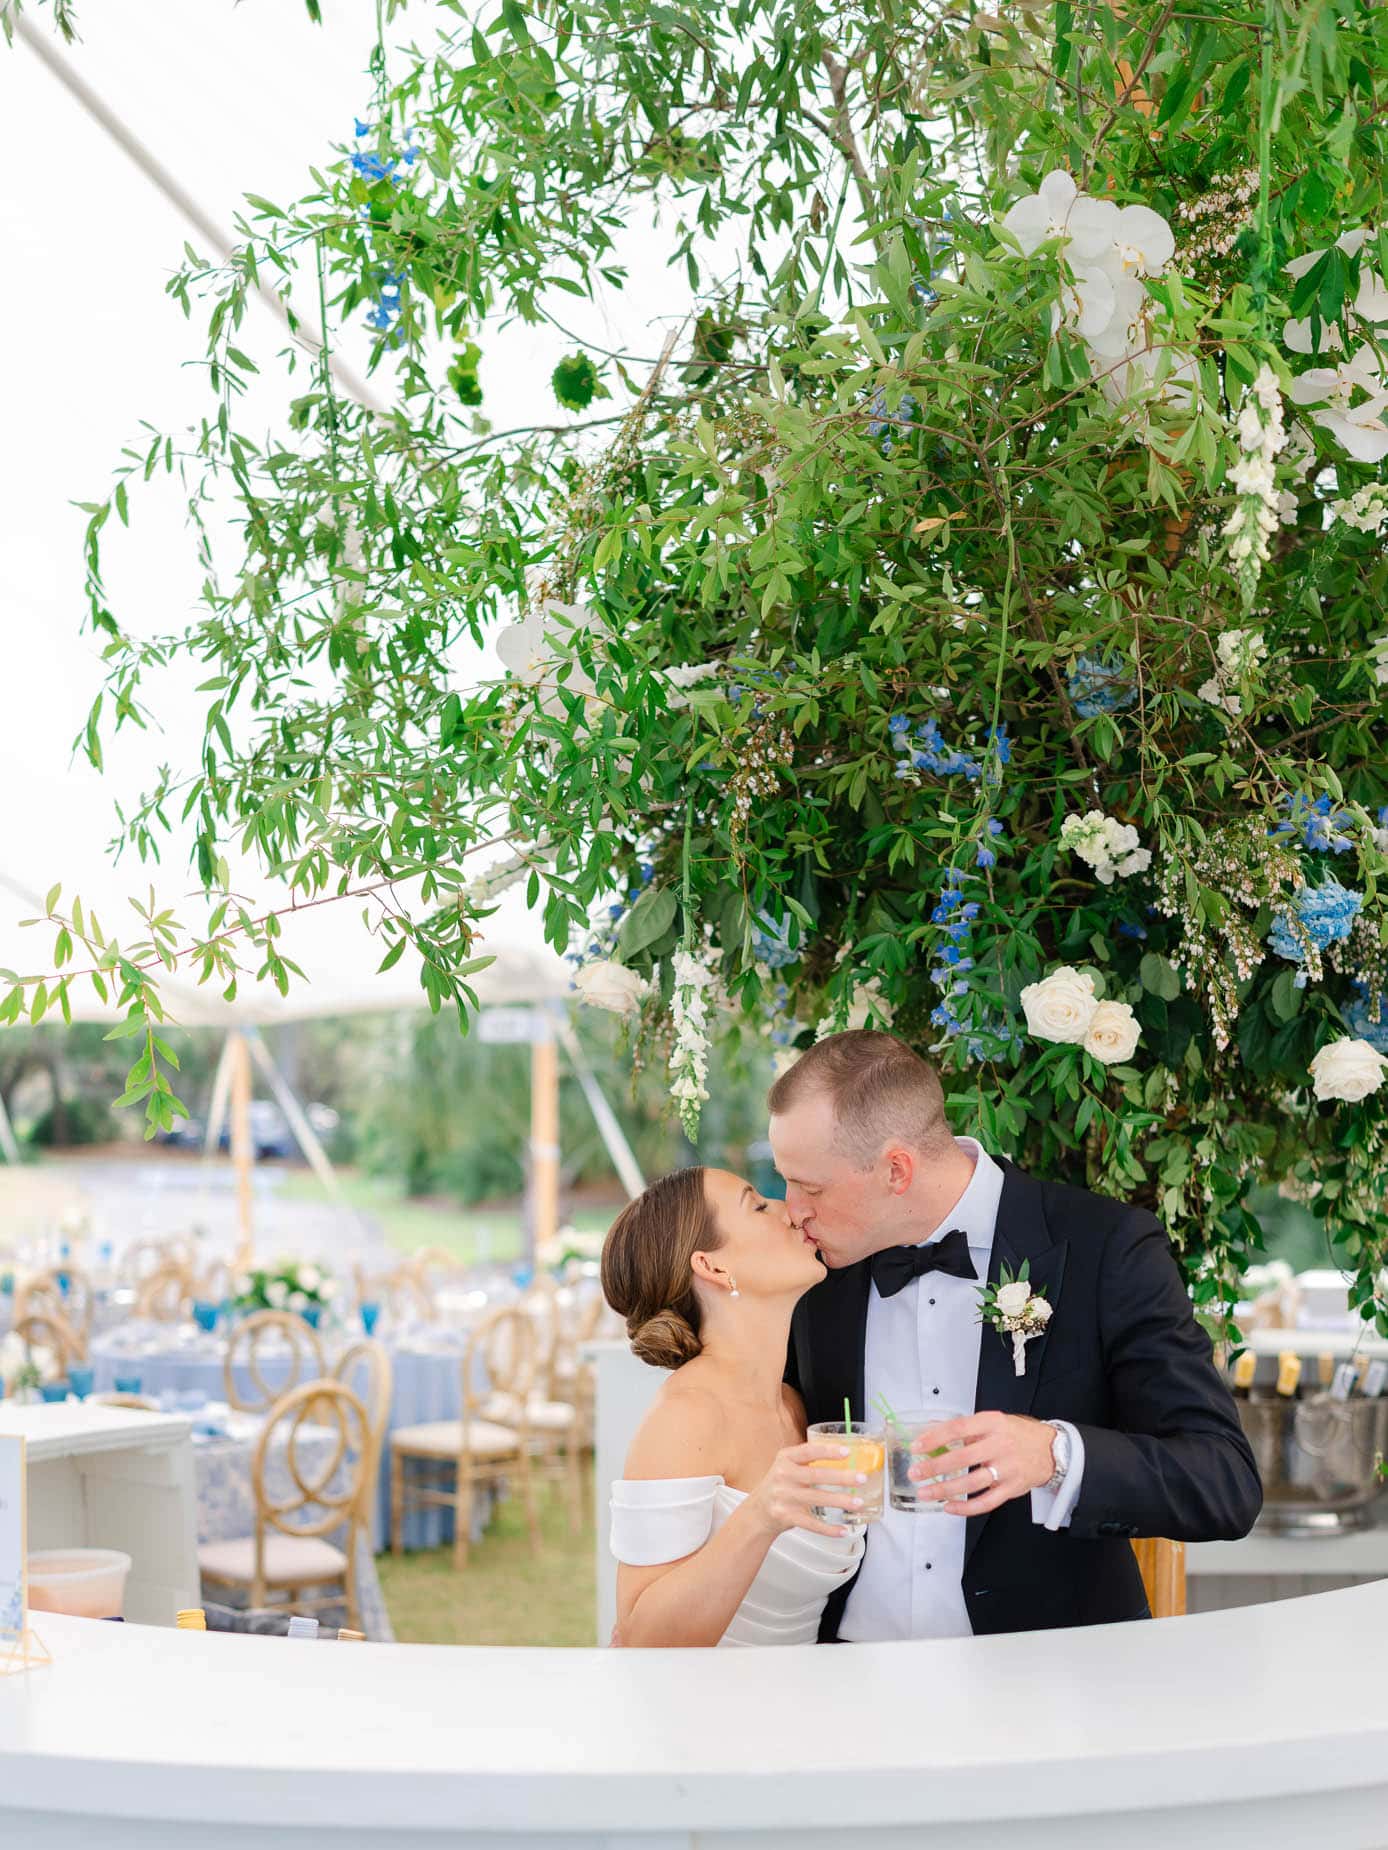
[10,0,1388,1330]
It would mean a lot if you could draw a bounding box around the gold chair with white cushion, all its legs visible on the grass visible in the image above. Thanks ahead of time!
[390,1308,540,1567]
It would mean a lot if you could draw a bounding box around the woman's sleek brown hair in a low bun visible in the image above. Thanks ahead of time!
[601,1166,722,1369]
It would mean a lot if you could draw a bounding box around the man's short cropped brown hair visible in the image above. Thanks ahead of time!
[766,1029,953,1169]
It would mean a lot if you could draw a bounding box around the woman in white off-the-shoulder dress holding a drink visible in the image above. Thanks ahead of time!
[601,1167,862,1645]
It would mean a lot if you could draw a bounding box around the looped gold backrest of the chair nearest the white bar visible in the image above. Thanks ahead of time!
[250,1380,374,1582]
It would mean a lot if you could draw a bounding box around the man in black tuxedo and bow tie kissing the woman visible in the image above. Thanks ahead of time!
[768,1030,1262,1643]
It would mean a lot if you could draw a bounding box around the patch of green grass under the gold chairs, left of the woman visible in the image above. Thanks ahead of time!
[376,1486,596,1645]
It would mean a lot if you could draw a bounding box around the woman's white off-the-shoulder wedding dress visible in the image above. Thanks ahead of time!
[611,1478,862,1645]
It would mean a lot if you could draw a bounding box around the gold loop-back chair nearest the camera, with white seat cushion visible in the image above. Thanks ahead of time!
[198,1380,374,1630]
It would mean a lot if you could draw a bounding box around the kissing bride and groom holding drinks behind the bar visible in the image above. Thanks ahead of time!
[601,1030,1262,1647]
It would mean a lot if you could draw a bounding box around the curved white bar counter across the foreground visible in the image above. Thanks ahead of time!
[0,1582,1388,1850]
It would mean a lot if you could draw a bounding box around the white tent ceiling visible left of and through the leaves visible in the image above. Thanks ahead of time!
[0,0,729,1025]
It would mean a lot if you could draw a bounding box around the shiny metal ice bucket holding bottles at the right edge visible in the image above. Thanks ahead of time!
[1238,1393,1388,1536]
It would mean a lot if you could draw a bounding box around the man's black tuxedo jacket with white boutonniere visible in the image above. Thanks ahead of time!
[787,1158,1262,1641]
